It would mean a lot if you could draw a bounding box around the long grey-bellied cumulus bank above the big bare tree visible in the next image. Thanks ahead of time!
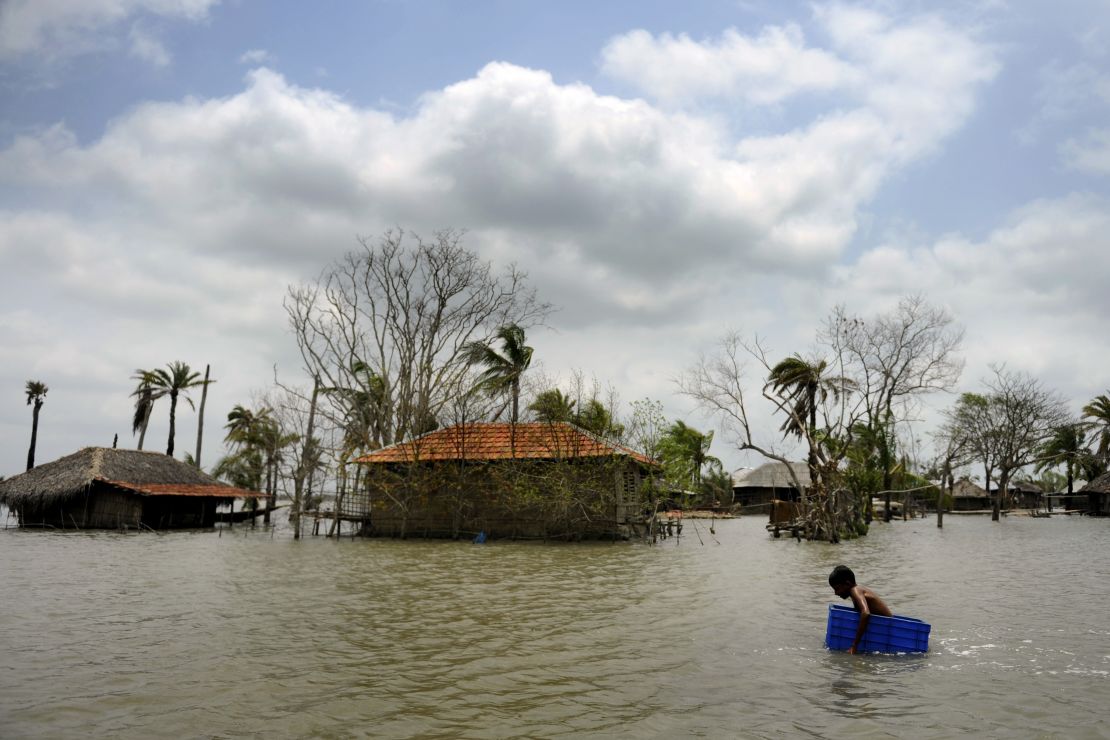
[0,57,919,307]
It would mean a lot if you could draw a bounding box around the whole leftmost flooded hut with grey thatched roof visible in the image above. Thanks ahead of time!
[0,447,262,529]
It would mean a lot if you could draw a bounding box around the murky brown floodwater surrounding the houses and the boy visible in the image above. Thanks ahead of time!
[0,516,1110,738]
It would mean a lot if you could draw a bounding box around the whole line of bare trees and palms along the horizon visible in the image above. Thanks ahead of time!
[15,231,1110,541]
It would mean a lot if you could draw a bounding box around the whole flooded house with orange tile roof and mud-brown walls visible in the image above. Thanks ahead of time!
[355,422,660,539]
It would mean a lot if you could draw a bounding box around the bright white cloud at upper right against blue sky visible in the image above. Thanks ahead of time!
[603,3,999,160]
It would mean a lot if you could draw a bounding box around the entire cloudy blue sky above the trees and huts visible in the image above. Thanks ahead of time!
[0,0,1110,476]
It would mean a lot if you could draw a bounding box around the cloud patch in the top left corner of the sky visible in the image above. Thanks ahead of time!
[0,0,219,59]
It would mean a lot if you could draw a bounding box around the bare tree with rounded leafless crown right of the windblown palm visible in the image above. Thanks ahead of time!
[823,295,963,521]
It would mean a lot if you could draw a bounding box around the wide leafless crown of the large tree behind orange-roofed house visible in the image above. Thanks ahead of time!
[284,230,551,449]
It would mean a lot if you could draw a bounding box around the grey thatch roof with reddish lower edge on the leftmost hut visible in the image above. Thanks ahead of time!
[0,447,262,506]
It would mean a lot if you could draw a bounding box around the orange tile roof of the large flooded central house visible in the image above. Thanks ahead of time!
[355,422,658,467]
